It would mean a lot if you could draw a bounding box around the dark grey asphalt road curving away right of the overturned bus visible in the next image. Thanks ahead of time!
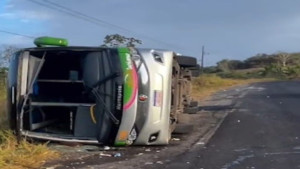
[157,81,300,169]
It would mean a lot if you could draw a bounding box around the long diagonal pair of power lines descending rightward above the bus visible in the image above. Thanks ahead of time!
[27,0,178,48]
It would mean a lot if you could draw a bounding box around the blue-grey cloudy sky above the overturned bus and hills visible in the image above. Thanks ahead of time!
[0,0,300,66]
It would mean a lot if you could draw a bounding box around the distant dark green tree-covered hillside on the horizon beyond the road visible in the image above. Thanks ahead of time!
[204,52,300,80]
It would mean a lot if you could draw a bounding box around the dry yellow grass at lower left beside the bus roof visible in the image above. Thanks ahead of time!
[0,80,59,169]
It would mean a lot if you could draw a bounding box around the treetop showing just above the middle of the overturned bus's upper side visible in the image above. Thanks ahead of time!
[102,34,142,47]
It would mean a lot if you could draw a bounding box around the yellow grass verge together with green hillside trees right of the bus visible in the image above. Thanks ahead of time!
[193,52,300,100]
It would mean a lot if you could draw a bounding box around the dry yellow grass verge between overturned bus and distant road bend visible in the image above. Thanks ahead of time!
[192,74,275,100]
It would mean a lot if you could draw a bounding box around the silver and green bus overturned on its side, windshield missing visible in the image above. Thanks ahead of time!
[7,37,199,146]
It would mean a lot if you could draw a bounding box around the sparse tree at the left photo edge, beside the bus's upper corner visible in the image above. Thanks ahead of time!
[0,45,19,68]
